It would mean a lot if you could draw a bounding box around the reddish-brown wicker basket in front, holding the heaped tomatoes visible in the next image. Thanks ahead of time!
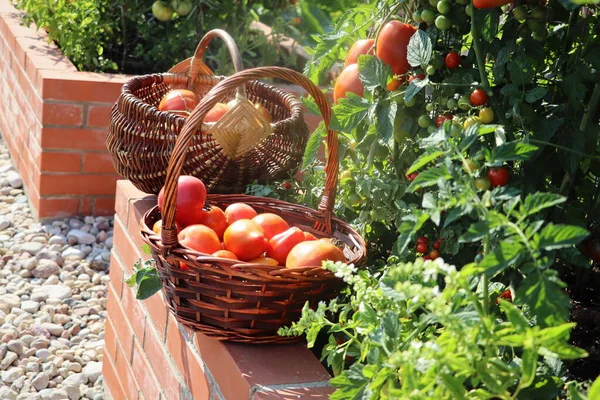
[142,67,366,343]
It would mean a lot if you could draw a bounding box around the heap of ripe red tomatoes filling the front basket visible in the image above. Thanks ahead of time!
[153,175,347,268]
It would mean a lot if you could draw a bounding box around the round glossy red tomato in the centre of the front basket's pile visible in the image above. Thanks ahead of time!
[223,219,267,261]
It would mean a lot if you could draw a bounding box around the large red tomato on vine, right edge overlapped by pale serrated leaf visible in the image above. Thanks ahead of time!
[376,20,417,75]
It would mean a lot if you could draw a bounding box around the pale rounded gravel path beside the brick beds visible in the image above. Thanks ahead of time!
[0,141,113,400]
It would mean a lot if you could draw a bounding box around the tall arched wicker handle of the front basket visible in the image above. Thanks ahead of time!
[161,67,339,251]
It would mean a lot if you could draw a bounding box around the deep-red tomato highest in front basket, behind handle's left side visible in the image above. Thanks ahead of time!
[158,175,206,228]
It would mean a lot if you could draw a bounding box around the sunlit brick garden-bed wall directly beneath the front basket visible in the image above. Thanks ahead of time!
[103,181,333,400]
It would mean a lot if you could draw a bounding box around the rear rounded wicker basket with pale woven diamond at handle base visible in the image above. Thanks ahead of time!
[106,29,309,194]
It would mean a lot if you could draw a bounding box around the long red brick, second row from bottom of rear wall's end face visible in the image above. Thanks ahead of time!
[40,174,119,196]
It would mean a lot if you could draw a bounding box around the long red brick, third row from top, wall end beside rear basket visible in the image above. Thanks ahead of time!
[40,127,106,150]
